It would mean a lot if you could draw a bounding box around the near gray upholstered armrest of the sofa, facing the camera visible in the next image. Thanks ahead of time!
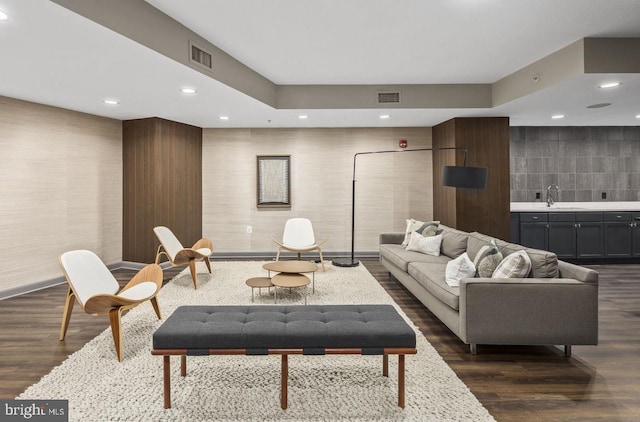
[460,278,598,345]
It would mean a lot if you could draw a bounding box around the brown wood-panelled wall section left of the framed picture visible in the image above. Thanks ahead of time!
[122,117,202,263]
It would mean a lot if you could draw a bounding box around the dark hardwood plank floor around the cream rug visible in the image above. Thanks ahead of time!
[0,260,640,422]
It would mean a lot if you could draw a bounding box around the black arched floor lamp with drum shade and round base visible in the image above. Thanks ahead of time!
[332,147,488,267]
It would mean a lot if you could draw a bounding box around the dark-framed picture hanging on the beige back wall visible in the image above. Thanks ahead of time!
[257,155,291,208]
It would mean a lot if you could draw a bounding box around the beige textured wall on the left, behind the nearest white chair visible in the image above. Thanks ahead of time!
[0,97,122,296]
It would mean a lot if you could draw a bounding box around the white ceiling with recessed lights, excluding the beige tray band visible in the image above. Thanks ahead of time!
[0,0,640,127]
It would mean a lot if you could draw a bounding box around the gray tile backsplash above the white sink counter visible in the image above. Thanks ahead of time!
[509,126,640,202]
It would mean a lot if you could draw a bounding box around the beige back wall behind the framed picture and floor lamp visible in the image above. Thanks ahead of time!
[202,128,433,254]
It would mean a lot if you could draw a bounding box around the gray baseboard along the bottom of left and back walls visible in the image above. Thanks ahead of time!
[0,251,378,300]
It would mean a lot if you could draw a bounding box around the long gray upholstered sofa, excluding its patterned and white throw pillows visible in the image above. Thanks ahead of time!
[380,225,598,356]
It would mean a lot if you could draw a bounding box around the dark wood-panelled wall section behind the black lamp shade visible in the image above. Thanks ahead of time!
[432,117,510,240]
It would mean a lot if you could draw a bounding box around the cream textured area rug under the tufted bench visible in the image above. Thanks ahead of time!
[17,261,494,422]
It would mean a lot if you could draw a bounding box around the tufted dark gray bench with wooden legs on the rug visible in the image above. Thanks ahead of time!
[151,305,416,409]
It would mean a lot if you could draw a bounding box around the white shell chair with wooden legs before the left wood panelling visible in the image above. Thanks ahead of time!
[153,226,213,289]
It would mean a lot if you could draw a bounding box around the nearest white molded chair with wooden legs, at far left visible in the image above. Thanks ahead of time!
[58,250,162,361]
